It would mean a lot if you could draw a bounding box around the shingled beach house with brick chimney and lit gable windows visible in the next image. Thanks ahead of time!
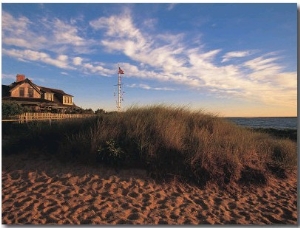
[2,74,81,113]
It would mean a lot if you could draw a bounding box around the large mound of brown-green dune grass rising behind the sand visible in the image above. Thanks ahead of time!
[3,105,297,186]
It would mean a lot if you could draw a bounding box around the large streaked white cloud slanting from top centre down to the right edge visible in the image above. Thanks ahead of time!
[90,11,296,108]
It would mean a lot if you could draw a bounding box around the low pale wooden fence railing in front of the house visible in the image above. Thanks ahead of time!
[2,112,95,123]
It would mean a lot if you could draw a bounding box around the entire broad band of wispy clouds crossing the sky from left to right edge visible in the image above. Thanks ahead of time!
[2,8,297,106]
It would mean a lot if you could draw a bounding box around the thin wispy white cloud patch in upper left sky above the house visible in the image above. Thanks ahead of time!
[2,11,96,54]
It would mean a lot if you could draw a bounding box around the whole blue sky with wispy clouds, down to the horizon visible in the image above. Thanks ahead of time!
[2,3,297,116]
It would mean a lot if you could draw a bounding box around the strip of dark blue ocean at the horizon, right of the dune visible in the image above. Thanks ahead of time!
[225,117,297,129]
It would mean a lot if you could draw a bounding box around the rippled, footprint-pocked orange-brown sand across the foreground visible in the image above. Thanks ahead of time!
[2,153,297,225]
